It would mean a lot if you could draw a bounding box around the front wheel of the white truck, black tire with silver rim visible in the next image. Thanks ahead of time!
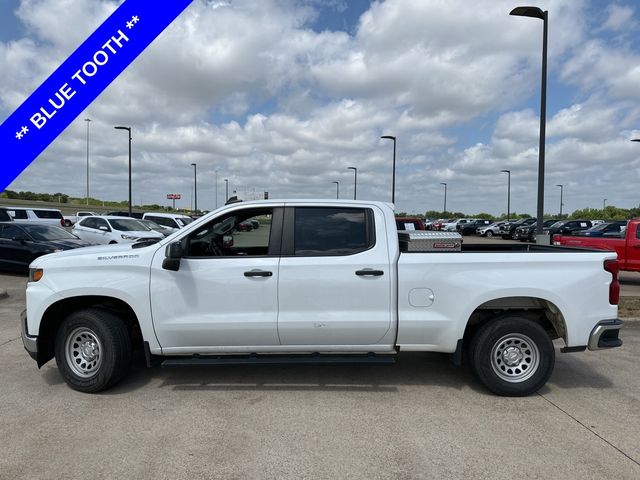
[55,308,131,393]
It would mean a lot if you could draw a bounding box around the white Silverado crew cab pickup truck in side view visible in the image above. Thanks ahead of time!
[22,200,622,396]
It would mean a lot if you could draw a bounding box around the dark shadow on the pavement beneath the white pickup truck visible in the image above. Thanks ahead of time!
[104,352,613,395]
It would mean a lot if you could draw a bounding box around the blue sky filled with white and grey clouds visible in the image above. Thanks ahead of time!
[0,0,640,214]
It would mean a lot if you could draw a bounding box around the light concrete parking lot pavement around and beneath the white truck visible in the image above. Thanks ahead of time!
[0,275,640,479]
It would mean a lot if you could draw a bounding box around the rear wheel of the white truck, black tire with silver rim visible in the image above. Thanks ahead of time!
[469,316,555,397]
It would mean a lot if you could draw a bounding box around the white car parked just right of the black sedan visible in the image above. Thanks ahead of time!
[73,216,164,244]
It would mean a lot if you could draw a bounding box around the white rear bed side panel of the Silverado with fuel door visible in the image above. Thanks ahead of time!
[397,252,617,352]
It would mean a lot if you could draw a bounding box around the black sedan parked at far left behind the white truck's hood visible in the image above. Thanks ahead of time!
[0,222,91,272]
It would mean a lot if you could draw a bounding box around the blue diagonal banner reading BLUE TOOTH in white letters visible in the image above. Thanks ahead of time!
[0,0,193,191]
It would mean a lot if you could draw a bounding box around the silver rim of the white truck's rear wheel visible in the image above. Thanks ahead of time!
[491,333,540,383]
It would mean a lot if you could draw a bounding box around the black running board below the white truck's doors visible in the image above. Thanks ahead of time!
[161,353,396,368]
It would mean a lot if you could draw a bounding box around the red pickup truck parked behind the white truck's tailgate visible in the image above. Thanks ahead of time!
[553,218,640,272]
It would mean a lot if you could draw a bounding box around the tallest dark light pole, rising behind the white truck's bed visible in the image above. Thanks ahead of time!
[509,7,549,235]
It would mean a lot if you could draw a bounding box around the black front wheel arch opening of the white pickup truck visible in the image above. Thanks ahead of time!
[38,295,143,367]
